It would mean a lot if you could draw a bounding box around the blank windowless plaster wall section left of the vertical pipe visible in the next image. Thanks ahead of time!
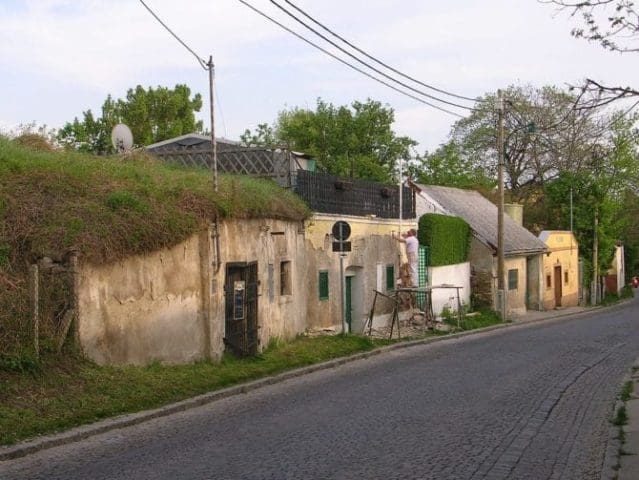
[77,233,208,365]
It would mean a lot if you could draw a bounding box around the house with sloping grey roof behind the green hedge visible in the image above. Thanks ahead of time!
[410,182,546,315]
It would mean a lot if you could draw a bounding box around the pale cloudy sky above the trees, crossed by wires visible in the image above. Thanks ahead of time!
[0,0,639,153]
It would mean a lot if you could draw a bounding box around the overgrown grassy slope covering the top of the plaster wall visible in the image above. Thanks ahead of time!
[0,138,309,267]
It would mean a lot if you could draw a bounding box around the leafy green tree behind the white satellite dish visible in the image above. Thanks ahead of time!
[58,85,202,154]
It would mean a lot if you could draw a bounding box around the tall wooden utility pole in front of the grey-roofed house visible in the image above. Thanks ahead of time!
[497,90,506,321]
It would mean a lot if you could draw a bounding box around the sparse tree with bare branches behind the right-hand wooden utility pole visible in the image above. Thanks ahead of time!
[444,86,597,201]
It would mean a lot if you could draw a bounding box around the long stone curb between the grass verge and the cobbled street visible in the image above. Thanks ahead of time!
[0,307,601,461]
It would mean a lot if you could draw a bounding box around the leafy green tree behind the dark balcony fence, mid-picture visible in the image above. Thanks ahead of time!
[242,99,417,182]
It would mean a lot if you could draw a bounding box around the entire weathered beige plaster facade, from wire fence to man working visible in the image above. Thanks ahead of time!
[78,215,424,364]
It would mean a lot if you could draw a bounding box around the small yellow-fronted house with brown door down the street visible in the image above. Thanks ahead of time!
[539,230,580,310]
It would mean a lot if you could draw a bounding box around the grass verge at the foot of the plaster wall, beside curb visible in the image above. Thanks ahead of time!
[0,335,390,445]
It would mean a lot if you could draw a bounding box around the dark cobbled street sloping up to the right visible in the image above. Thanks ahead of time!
[0,298,639,480]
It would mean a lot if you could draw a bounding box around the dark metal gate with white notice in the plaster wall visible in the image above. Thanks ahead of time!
[224,262,258,356]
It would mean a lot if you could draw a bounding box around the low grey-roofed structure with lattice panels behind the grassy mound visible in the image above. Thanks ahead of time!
[146,133,315,187]
